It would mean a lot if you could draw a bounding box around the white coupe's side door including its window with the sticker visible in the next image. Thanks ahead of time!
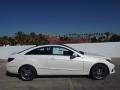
[48,46,83,75]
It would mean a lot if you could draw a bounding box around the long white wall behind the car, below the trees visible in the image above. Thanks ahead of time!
[0,42,120,59]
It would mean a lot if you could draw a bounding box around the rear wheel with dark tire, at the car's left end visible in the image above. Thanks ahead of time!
[19,65,37,81]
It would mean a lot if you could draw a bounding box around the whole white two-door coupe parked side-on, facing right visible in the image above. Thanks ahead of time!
[6,45,115,81]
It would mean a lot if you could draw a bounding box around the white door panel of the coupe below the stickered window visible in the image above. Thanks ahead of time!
[44,55,83,74]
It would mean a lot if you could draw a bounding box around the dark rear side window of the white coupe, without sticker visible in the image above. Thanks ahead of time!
[25,47,52,55]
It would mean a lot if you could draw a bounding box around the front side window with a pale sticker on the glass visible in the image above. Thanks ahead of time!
[52,47,73,56]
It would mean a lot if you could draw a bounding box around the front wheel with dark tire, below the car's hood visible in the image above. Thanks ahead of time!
[90,64,109,80]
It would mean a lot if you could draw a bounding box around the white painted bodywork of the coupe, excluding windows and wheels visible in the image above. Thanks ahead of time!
[7,45,115,80]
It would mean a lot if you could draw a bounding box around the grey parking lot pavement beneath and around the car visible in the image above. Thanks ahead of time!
[0,59,120,90]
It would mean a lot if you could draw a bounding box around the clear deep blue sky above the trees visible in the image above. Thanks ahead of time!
[0,0,120,36]
